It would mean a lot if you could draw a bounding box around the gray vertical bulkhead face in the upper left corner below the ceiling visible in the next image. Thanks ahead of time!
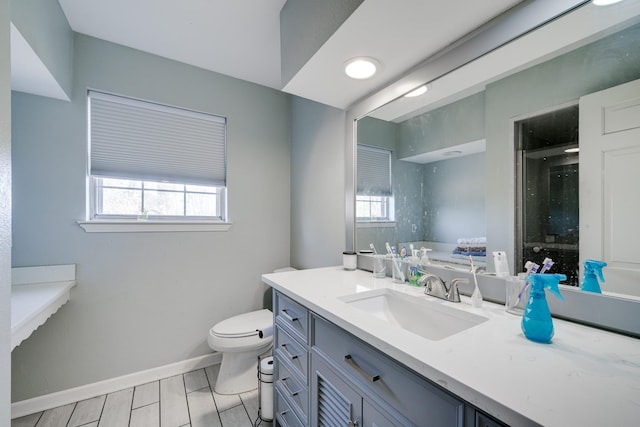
[11,0,73,98]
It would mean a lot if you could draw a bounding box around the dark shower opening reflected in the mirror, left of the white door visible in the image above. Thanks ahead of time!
[514,105,580,286]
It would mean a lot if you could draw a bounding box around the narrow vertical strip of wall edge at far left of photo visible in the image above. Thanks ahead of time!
[0,0,11,426]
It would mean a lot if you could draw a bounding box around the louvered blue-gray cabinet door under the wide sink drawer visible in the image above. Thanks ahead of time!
[310,353,362,427]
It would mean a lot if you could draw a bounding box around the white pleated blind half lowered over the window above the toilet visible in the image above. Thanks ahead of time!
[89,91,226,187]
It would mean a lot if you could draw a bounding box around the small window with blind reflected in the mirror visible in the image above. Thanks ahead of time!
[356,145,394,222]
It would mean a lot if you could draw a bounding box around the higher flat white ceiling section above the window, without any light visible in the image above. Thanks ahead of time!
[58,0,285,89]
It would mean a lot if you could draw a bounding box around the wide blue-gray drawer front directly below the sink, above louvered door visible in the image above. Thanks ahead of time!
[313,316,464,426]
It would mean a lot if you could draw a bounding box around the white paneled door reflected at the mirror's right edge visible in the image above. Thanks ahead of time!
[580,80,640,296]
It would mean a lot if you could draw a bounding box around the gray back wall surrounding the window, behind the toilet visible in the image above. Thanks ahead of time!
[11,35,292,401]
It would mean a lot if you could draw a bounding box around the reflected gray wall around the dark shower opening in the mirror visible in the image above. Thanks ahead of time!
[486,25,640,272]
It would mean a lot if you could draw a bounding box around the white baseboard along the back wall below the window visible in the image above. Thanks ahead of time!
[11,352,222,419]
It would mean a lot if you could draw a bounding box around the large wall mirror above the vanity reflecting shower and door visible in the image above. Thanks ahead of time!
[347,0,640,332]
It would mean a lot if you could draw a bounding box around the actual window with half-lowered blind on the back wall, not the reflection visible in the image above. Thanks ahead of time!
[84,91,226,221]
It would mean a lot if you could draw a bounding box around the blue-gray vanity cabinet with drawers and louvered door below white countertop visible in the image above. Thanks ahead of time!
[273,291,502,427]
